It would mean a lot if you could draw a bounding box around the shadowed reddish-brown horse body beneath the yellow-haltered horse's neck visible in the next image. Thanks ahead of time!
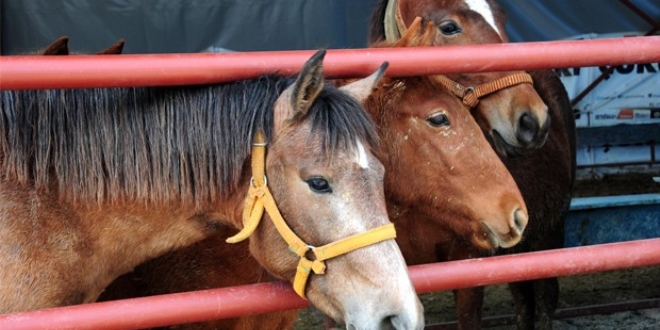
[99,227,298,330]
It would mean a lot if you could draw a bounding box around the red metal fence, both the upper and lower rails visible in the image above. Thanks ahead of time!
[0,37,660,329]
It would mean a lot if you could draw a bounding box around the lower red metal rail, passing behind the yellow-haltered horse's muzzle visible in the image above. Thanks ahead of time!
[0,238,660,330]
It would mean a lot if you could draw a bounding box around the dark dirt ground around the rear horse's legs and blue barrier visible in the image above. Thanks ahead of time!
[295,174,660,330]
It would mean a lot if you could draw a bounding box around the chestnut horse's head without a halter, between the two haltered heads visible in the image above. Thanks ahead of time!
[365,72,528,253]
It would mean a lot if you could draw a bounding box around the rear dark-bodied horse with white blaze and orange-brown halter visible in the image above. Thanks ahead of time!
[369,0,576,329]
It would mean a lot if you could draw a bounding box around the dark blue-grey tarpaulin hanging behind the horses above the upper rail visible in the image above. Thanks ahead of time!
[0,0,660,54]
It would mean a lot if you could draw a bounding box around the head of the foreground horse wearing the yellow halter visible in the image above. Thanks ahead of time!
[242,52,424,329]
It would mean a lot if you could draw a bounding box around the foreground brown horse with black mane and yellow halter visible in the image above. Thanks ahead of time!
[0,51,424,329]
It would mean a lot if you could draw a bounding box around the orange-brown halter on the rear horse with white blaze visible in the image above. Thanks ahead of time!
[383,0,534,108]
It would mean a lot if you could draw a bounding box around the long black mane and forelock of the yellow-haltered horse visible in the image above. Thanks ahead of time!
[0,76,376,203]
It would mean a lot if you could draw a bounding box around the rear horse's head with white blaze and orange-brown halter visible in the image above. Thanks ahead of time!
[376,0,550,157]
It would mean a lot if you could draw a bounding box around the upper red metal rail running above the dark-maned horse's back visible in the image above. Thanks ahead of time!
[0,36,660,89]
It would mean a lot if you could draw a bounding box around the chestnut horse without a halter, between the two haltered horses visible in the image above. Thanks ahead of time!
[103,21,527,329]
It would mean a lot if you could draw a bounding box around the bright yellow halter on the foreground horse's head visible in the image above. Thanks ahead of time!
[226,131,396,299]
